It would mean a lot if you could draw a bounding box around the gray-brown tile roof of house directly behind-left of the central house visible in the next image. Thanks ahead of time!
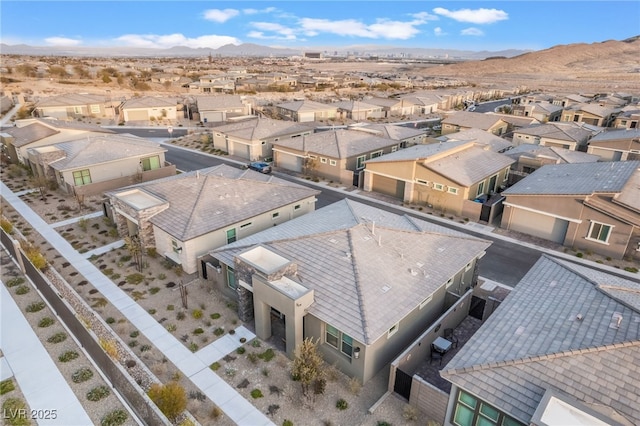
[107,165,320,241]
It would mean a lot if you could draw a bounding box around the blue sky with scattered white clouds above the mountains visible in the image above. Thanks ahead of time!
[0,0,640,51]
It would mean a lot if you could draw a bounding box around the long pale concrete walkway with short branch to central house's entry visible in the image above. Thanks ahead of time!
[0,182,273,426]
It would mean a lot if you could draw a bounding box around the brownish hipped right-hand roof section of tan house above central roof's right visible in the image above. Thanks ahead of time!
[422,145,515,186]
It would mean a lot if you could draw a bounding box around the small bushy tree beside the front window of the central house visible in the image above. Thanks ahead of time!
[291,338,325,400]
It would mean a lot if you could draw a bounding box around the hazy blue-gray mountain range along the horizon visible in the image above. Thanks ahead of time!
[0,43,527,60]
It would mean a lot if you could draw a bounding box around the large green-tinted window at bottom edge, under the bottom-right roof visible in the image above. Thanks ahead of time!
[452,390,523,426]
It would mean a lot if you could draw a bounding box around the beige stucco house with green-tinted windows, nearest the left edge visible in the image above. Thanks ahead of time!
[27,134,176,195]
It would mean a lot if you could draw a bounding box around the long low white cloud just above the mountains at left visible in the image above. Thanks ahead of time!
[116,34,241,49]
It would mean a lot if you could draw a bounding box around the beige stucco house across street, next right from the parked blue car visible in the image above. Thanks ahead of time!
[273,129,400,186]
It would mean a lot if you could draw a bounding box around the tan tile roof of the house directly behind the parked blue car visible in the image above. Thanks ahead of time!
[213,118,313,141]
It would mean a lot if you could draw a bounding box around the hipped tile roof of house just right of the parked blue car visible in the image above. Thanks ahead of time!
[274,129,398,158]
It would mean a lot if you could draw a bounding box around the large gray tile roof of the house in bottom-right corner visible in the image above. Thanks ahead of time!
[441,255,640,424]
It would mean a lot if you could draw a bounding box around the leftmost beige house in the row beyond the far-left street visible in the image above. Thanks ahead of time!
[33,93,119,120]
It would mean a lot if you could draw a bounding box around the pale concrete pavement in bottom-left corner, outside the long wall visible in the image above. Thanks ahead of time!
[0,284,92,426]
